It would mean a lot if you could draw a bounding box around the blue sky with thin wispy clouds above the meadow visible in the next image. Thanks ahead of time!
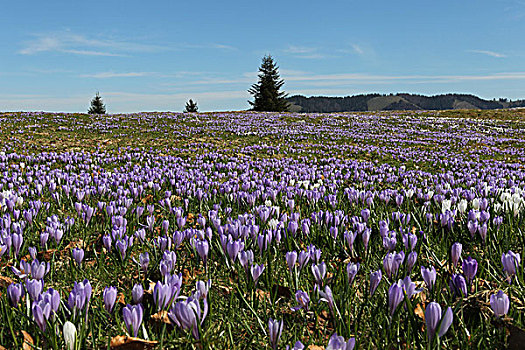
[0,0,525,113]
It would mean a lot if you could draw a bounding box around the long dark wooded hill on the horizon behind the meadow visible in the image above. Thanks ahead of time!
[287,94,525,113]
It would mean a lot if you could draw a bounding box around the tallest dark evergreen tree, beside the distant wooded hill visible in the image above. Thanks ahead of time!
[248,55,289,112]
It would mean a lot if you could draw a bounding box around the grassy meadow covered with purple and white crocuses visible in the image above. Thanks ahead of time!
[0,110,525,349]
